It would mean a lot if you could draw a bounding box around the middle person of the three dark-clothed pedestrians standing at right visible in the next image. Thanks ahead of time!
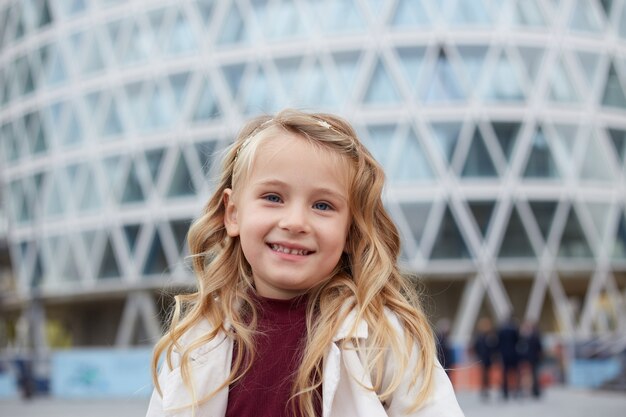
[498,317,520,400]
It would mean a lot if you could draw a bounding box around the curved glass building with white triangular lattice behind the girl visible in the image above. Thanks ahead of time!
[0,0,626,352]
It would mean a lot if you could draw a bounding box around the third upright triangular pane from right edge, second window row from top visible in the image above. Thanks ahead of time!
[483,52,525,101]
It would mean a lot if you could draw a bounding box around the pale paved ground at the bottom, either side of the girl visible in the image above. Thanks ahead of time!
[0,388,626,417]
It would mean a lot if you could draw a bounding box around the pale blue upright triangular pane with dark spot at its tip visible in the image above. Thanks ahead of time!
[422,49,465,103]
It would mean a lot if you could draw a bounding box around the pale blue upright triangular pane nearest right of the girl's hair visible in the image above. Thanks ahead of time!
[391,130,435,182]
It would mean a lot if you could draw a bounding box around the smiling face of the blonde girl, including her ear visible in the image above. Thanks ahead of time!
[224,131,350,299]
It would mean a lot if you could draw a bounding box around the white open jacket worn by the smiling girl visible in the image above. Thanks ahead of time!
[146,311,463,417]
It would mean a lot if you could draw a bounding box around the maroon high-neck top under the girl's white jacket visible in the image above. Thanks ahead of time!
[226,295,321,417]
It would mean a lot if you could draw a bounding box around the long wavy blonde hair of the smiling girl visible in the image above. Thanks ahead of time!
[152,109,435,417]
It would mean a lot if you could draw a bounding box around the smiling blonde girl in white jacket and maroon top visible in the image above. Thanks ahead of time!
[148,110,463,417]
